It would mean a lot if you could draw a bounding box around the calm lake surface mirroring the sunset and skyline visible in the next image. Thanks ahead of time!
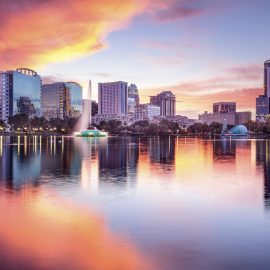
[0,136,270,270]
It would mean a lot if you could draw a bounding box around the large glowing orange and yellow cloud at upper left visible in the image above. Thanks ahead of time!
[0,0,147,69]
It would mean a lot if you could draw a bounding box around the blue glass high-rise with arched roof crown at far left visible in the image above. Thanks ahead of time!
[0,68,41,121]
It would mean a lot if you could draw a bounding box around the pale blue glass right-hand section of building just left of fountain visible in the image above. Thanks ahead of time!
[65,82,82,118]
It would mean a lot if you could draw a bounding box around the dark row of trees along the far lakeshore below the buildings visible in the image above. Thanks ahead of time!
[0,114,270,136]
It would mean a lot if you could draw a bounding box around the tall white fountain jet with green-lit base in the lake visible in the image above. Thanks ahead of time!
[74,80,108,137]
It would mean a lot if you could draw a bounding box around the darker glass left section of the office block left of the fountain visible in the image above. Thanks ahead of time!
[41,82,71,119]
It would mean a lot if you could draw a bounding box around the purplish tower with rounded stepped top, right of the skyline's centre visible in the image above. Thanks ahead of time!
[150,91,176,116]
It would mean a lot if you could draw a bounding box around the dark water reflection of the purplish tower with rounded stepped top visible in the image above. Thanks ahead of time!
[149,137,175,164]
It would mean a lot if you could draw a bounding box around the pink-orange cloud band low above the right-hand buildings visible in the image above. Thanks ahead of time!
[142,64,263,118]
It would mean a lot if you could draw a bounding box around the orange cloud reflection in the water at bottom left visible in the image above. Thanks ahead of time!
[0,188,152,270]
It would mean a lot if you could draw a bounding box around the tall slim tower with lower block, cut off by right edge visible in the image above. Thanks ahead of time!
[256,60,270,121]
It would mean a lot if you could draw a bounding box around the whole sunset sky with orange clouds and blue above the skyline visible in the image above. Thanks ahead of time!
[0,0,270,118]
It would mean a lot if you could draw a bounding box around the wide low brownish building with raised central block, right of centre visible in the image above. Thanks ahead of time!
[199,102,251,125]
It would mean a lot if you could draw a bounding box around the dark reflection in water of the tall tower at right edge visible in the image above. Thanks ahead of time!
[256,140,270,210]
